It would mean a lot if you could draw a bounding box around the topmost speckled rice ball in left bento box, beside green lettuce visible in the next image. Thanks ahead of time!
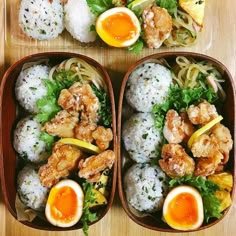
[15,65,50,113]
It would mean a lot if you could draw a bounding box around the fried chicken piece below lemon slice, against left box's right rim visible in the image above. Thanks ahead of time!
[78,150,115,181]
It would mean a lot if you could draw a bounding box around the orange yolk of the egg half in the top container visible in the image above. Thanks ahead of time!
[102,12,137,42]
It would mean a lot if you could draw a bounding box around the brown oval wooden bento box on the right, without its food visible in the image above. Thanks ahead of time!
[117,52,236,232]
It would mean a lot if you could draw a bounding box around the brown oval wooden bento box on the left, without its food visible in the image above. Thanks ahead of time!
[0,52,117,231]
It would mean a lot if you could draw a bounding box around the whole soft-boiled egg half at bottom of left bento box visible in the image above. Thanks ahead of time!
[45,179,84,227]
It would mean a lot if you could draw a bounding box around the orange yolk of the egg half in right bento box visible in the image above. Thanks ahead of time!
[167,193,198,225]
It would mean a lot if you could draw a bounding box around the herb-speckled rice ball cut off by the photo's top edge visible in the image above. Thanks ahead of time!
[19,0,64,40]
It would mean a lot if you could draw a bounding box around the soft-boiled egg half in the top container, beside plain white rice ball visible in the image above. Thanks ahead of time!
[96,7,141,47]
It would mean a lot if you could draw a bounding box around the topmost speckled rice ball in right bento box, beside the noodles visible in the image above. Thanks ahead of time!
[125,62,172,112]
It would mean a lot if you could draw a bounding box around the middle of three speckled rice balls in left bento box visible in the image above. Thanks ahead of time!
[13,117,50,163]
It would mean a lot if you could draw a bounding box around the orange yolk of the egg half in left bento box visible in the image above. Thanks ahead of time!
[48,186,78,222]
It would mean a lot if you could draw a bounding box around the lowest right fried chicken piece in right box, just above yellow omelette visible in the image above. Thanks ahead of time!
[194,150,224,176]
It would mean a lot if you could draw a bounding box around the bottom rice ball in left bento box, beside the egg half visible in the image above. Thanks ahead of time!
[17,165,49,211]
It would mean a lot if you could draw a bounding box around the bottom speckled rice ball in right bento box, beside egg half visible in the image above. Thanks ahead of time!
[124,163,168,213]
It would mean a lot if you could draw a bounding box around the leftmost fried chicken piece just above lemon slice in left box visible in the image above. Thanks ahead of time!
[42,110,79,138]
